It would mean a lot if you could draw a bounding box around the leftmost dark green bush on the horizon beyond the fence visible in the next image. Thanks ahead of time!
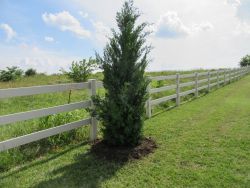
[0,66,23,82]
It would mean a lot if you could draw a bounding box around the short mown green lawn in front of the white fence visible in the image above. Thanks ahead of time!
[0,76,250,188]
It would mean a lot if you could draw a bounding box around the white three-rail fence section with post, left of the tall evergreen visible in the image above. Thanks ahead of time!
[0,79,103,152]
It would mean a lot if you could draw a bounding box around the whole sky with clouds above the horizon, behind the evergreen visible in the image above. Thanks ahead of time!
[0,0,250,74]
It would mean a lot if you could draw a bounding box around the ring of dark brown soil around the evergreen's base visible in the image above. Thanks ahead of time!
[90,138,157,162]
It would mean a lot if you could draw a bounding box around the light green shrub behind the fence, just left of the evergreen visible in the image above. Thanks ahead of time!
[61,58,97,82]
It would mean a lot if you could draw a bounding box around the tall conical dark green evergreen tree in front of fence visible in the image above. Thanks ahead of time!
[93,1,151,145]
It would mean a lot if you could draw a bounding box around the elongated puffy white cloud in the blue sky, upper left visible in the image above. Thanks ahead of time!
[42,11,91,38]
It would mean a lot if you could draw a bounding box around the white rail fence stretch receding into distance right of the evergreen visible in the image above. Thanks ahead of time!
[146,67,250,118]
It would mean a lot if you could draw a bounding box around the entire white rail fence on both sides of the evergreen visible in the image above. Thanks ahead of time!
[0,68,250,152]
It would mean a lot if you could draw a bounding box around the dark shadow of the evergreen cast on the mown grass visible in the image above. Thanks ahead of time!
[34,148,125,188]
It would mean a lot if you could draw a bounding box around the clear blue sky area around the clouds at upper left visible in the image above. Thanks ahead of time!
[0,0,96,57]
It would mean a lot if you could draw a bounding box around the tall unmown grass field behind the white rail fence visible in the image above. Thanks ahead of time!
[0,70,212,172]
